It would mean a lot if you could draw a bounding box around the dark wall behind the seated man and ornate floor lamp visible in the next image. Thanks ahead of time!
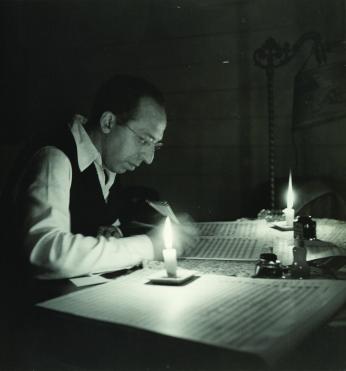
[0,0,346,220]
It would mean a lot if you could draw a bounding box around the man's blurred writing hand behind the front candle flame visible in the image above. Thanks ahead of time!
[148,215,198,260]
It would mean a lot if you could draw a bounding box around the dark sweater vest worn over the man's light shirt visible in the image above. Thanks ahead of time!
[0,127,126,293]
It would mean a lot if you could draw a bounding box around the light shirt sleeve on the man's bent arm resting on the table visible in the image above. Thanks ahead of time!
[21,147,154,279]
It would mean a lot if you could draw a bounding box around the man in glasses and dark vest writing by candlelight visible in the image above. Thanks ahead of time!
[4,75,194,279]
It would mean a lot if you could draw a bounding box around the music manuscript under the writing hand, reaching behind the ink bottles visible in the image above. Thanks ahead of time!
[192,219,346,265]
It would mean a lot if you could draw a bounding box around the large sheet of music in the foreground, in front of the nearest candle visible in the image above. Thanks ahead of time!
[38,272,346,364]
